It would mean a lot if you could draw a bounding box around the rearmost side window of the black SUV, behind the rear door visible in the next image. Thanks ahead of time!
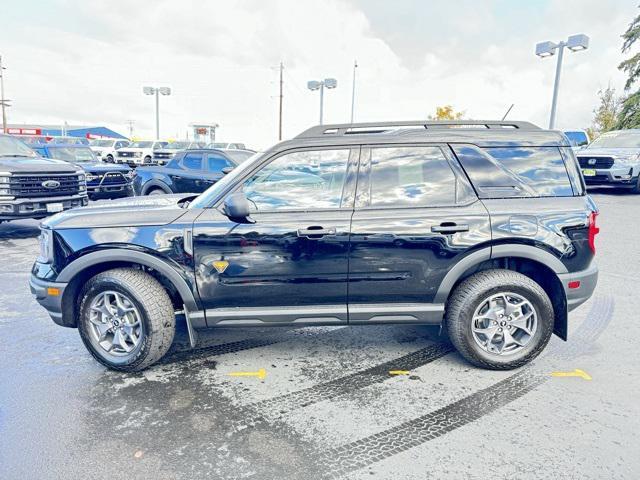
[484,147,573,197]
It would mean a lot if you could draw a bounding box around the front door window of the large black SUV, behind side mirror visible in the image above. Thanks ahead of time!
[244,149,349,211]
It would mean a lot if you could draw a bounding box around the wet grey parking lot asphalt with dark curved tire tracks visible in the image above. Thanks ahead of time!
[0,191,640,480]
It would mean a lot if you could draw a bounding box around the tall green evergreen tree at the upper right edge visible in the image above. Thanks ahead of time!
[616,7,640,128]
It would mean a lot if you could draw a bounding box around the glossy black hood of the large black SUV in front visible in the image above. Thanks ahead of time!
[42,194,194,229]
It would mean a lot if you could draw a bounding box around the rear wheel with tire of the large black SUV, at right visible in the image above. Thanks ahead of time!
[445,269,554,370]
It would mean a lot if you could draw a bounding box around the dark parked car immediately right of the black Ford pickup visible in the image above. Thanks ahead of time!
[33,144,134,199]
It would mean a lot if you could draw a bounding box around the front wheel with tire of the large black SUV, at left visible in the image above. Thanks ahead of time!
[78,268,176,372]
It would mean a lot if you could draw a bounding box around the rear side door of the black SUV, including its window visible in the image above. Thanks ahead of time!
[349,144,490,323]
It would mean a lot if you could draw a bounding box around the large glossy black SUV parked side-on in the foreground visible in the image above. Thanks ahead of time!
[31,121,598,371]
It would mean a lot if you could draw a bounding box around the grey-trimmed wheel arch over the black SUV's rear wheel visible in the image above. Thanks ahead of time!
[434,245,568,340]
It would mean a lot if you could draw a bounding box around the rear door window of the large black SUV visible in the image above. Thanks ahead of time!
[371,147,456,207]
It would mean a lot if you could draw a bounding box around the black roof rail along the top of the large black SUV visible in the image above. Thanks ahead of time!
[295,120,540,138]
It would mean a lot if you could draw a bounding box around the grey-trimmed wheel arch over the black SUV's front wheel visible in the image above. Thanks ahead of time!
[57,249,200,327]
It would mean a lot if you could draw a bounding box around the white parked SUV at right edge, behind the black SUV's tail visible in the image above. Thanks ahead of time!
[577,129,640,193]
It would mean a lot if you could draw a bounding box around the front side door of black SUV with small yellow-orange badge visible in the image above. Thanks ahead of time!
[193,147,359,325]
